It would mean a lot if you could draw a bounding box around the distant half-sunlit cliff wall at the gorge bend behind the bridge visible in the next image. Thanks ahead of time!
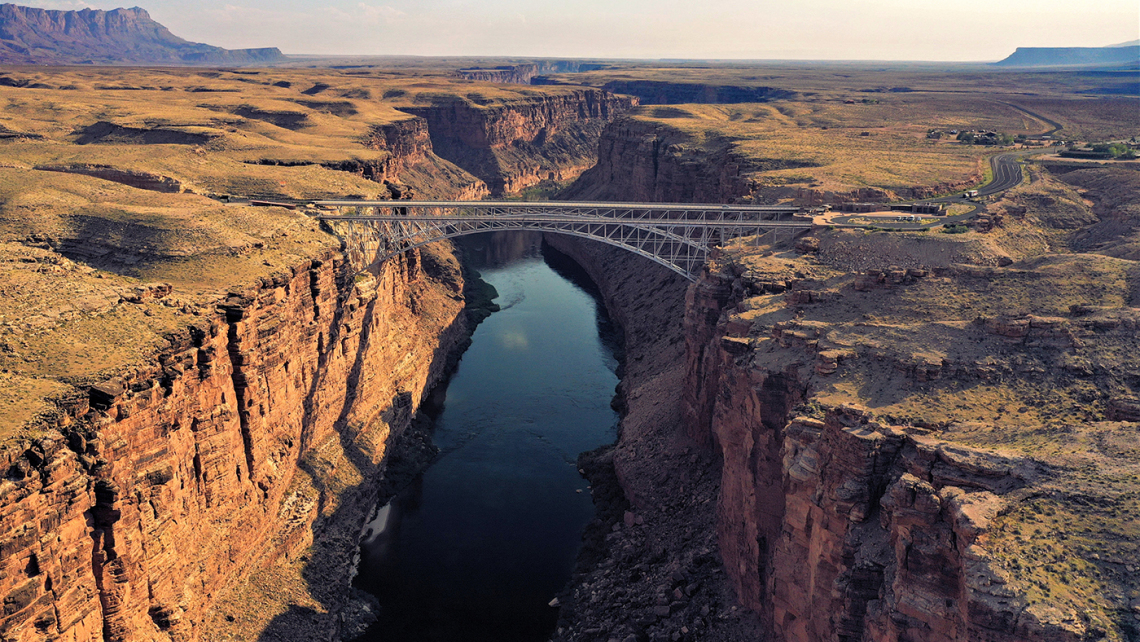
[404,89,635,195]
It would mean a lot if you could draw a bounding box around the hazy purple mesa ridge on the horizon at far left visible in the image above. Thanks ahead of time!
[0,3,284,65]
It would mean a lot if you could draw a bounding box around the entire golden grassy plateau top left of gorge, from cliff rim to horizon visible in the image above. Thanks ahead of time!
[0,67,629,444]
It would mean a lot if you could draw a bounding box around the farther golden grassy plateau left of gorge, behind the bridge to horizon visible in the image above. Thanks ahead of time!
[0,67,615,198]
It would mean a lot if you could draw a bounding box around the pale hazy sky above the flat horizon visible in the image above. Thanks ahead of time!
[15,0,1140,60]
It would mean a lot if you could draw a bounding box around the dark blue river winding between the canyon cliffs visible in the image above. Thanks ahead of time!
[356,233,618,642]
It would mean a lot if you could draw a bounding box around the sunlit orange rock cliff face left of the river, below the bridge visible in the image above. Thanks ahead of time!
[0,252,466,641]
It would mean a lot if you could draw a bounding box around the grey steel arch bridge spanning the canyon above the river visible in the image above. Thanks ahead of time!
[314,201,812,281]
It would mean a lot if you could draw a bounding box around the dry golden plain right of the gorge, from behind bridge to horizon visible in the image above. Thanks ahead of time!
[547,63,1140,201]
